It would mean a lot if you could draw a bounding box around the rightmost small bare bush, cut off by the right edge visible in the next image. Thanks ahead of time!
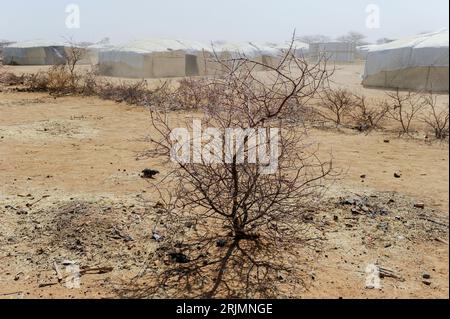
[422,94,449,140]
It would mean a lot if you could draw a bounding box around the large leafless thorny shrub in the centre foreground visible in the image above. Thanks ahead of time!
[129,40,331,298]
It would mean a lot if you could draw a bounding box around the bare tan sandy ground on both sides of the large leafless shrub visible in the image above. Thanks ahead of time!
[0,65,449,298]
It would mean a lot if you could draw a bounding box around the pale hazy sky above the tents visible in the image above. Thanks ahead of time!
[0,0,449,43]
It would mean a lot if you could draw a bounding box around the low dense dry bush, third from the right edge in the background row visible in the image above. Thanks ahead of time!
[350,94,388,132]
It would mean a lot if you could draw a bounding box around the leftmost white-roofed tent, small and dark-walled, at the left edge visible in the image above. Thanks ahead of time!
[3,40,70,65]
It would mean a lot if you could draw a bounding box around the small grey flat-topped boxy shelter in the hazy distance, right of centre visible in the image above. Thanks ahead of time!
[309,42,356,63]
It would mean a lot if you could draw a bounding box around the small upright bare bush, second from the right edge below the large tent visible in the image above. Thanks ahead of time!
[384,90,425,135]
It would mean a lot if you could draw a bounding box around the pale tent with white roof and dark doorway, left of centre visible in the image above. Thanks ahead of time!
[99,39,211,78]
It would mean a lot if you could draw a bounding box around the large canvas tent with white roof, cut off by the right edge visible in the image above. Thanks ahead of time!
[363,29,449,92]
